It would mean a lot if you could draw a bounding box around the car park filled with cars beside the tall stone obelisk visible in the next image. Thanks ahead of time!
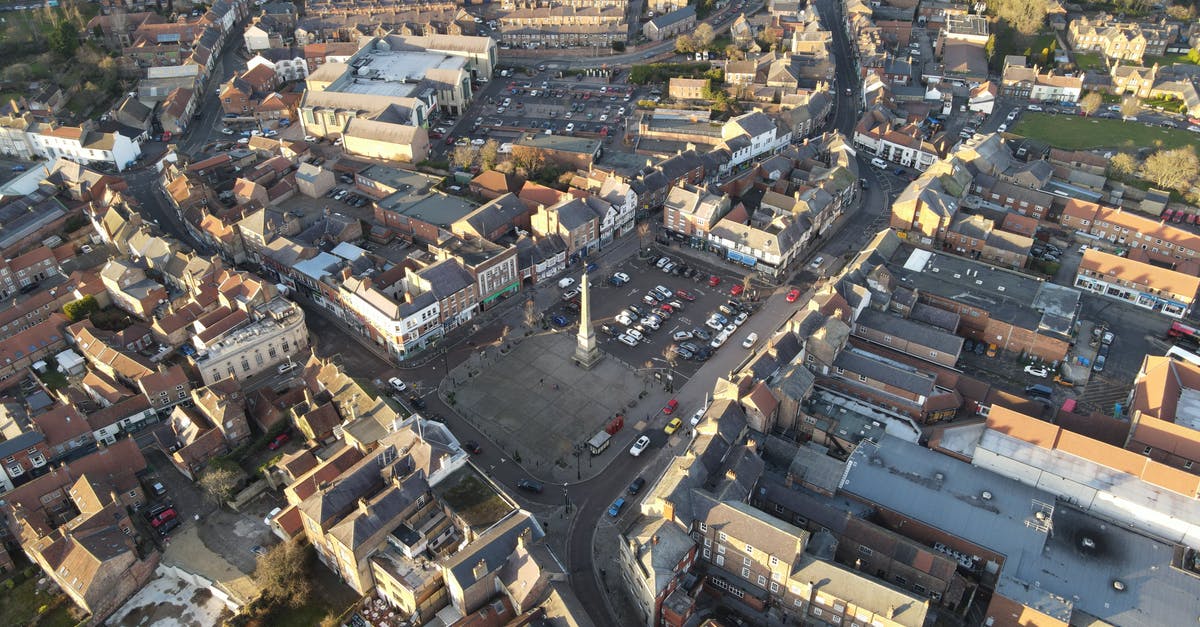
[546,255,757,386]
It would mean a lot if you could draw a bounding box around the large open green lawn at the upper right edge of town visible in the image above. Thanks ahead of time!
[1009,113,1200,150]
